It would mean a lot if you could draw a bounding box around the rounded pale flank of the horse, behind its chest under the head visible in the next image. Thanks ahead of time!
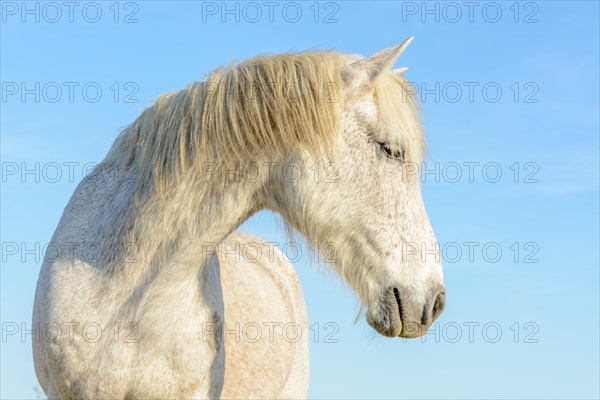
[217,232,309,398]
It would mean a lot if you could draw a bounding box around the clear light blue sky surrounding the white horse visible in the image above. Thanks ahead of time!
[0,1,600,399]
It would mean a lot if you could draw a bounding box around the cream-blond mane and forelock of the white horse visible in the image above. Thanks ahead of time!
[99,51,424,195]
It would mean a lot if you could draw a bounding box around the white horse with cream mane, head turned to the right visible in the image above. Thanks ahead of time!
[33,39,445,399]
